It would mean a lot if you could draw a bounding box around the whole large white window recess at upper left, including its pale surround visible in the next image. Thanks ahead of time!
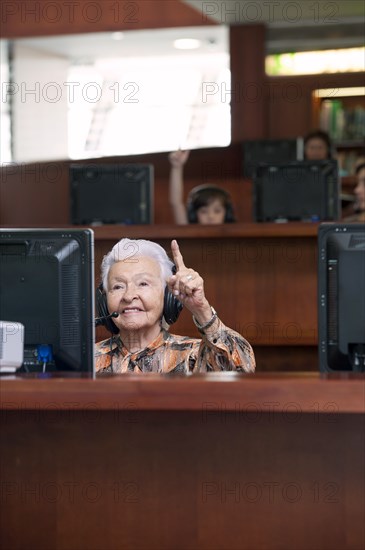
[2,25,231,162]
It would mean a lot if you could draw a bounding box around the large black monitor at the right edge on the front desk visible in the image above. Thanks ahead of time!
[318,223,365,372]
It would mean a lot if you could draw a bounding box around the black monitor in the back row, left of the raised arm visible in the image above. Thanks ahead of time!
[70,164,153,225]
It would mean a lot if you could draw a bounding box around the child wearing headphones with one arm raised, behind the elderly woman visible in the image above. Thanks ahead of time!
[169,150,236,225]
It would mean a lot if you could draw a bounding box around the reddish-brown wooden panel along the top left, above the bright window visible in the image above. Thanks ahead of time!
[1,0,216,38]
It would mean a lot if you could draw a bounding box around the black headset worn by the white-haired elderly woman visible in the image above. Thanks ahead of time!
[95,265,183,334]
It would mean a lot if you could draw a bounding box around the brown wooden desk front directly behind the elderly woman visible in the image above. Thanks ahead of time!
[94,223,318,370]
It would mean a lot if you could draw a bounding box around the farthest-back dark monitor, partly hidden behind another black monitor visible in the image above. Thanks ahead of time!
[243,138,304,178]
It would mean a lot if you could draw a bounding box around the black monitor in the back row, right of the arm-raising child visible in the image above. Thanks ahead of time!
[253,159,340,222]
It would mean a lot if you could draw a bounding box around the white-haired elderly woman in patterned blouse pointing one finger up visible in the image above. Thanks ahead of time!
[95,239,255,374]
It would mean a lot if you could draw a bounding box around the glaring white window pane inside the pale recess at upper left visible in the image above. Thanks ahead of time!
[68,53,230,159]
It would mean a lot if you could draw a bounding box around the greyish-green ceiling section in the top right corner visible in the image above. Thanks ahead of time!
[182,0,365,53]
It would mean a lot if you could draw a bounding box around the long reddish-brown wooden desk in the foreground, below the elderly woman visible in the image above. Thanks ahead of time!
[0,373,365,550]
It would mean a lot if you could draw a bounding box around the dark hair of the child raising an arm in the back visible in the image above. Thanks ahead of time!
[187,184,236,223]
